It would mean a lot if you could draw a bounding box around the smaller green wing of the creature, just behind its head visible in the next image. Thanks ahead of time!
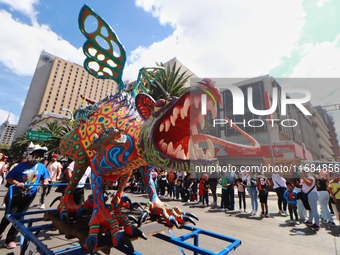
[131,66,165,97]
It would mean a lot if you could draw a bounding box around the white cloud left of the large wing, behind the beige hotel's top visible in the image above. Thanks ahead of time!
[0,10,84,75]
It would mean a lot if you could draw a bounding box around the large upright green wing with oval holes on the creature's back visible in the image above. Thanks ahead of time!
[78,5,126,91]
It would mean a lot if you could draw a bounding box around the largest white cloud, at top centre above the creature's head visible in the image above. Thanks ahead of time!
[128,0,305,77]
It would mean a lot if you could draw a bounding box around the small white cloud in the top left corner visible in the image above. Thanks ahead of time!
[0,0,39,24]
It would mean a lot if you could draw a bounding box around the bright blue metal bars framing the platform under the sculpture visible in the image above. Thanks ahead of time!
[6,184,241,255]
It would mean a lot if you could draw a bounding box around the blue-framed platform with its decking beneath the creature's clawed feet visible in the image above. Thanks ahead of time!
[6,184,241,255]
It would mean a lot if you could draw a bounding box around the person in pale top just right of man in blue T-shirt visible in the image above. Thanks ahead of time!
[40,154,63,210]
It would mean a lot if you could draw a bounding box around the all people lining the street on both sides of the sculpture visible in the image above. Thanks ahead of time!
[0,147,340,249]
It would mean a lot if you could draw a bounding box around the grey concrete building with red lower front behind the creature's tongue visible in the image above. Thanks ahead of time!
[206,75,334,165]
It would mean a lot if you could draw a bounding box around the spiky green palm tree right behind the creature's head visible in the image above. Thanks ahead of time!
[149,63,191,101]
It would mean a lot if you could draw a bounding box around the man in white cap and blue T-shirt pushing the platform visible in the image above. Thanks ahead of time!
[0,143,50,249]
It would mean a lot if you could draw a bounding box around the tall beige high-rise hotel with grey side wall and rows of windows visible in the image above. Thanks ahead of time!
[14,51,117,139]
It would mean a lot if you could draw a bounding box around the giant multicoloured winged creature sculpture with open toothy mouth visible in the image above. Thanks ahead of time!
[58,5,260,251]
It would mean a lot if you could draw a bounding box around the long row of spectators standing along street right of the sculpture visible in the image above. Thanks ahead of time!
[127,165,340,230]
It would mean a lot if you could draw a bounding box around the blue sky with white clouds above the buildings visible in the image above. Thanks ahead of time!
[0,0,340,140]
